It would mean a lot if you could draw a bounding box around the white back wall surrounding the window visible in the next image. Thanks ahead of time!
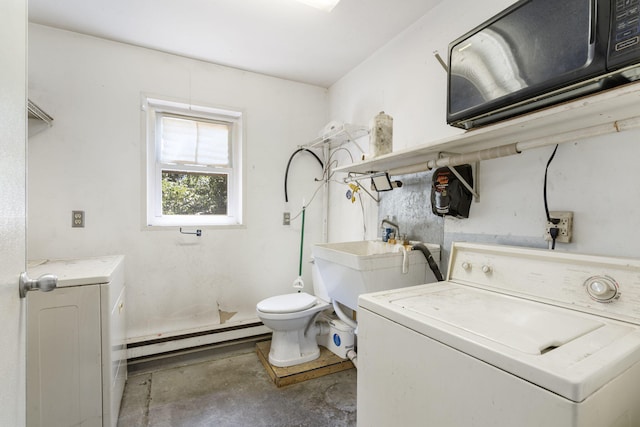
[28,25,327,341]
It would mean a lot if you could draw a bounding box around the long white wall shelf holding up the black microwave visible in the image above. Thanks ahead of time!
[335,82,640,175]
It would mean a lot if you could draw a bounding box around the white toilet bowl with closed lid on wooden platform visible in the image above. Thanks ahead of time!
[256,292,331,367]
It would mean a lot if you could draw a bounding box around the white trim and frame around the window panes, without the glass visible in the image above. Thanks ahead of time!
[142,95,245,228]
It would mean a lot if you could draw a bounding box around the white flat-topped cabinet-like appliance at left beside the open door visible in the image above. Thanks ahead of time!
[26,255,127,427]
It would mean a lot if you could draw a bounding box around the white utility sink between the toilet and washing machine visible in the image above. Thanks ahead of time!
[313,240,440,310]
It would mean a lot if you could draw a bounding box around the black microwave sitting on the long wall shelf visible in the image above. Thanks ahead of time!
[447,0,640,129]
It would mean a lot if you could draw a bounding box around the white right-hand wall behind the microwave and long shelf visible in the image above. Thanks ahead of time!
[329,0,640,257]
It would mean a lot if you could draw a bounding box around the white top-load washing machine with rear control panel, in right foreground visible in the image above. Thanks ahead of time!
[357,243,640,427]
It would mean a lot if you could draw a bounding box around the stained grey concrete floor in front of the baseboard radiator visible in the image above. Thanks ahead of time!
[118,344,356,427]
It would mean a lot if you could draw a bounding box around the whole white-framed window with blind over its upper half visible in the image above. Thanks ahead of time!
[144,98,242,226]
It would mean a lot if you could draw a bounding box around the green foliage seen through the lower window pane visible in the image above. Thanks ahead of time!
[162,171,227,215]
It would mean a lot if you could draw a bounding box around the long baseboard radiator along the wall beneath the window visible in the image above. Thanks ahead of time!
[127,322,271,363]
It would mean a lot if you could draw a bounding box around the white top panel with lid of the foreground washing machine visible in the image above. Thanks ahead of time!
[359,282,640,402]
